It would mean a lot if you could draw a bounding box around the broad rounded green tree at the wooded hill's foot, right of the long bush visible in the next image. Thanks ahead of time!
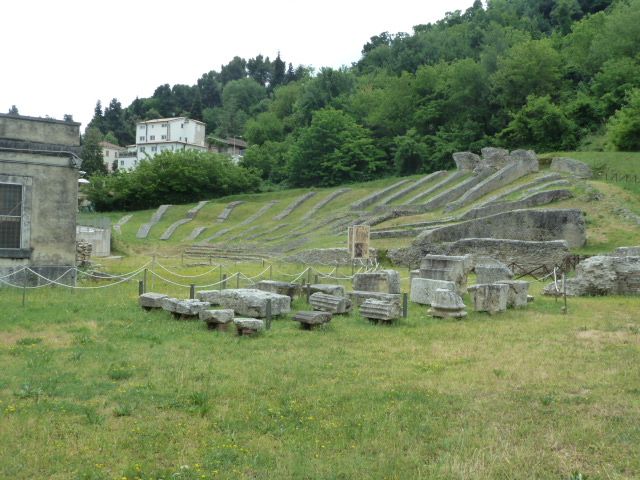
[289,108,385,187]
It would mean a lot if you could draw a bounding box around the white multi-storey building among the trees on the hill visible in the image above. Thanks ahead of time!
[134,117,207,162]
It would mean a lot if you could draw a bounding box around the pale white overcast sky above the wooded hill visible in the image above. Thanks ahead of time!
[0,0,473,130]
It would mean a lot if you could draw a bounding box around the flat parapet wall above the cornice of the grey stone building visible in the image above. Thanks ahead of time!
[0,113,80,146]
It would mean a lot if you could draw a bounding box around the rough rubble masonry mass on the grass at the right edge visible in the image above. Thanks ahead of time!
[543,255,640,296]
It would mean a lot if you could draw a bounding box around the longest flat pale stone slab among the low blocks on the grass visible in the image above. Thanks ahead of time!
[197,288,291,318]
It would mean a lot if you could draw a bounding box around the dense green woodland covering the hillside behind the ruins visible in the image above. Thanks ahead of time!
[82,0,640,209]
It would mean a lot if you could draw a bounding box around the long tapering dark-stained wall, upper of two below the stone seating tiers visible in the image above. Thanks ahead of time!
[413,209,586,247]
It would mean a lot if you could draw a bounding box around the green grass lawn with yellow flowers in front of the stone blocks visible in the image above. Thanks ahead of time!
[0,259,640,479]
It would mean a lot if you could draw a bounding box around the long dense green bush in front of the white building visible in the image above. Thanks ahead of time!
[87,150,260,211]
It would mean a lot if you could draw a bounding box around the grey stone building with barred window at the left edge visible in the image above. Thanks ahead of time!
[0,114,81,284]
